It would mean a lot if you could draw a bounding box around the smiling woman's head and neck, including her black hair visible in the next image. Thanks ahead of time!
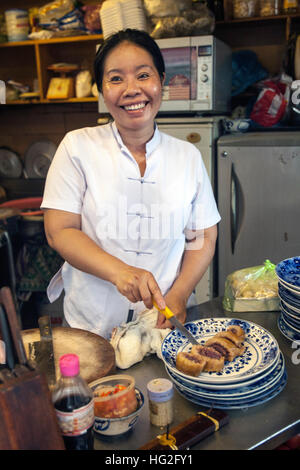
[95,30,165,162]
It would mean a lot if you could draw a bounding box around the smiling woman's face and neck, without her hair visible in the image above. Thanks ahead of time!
[102,41,162,147]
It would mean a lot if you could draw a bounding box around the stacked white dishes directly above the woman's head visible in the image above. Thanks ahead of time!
[100,0,147,39]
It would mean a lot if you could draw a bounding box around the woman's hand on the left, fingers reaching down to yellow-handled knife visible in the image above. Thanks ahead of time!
[114,265,166,309]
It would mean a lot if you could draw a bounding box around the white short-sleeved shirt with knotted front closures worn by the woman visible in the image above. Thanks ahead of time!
[41,123,220,338]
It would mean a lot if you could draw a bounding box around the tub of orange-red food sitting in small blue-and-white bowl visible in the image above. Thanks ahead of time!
[94,375,138,418]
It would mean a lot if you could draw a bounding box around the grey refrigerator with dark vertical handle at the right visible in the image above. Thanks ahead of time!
[216,131,300,295]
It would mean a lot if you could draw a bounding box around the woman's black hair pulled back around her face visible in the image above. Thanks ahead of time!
[94,28,165,93]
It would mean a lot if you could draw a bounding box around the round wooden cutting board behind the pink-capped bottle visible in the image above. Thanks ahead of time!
[21,327,115,383]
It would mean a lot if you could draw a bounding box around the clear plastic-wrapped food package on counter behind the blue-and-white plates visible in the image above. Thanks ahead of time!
[223,260,279,312]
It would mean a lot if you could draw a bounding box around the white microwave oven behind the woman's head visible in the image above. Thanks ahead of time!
[99,35,232,114]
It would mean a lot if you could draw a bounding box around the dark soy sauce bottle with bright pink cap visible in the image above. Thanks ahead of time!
[52,354,94,450]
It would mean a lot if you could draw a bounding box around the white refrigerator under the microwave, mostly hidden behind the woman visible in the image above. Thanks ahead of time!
[156,115,224,304]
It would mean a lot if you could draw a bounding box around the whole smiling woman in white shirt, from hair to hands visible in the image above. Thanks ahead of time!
[42,29,220,337]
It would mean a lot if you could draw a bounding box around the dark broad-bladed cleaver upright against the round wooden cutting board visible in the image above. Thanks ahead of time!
[29,315,56,389]
